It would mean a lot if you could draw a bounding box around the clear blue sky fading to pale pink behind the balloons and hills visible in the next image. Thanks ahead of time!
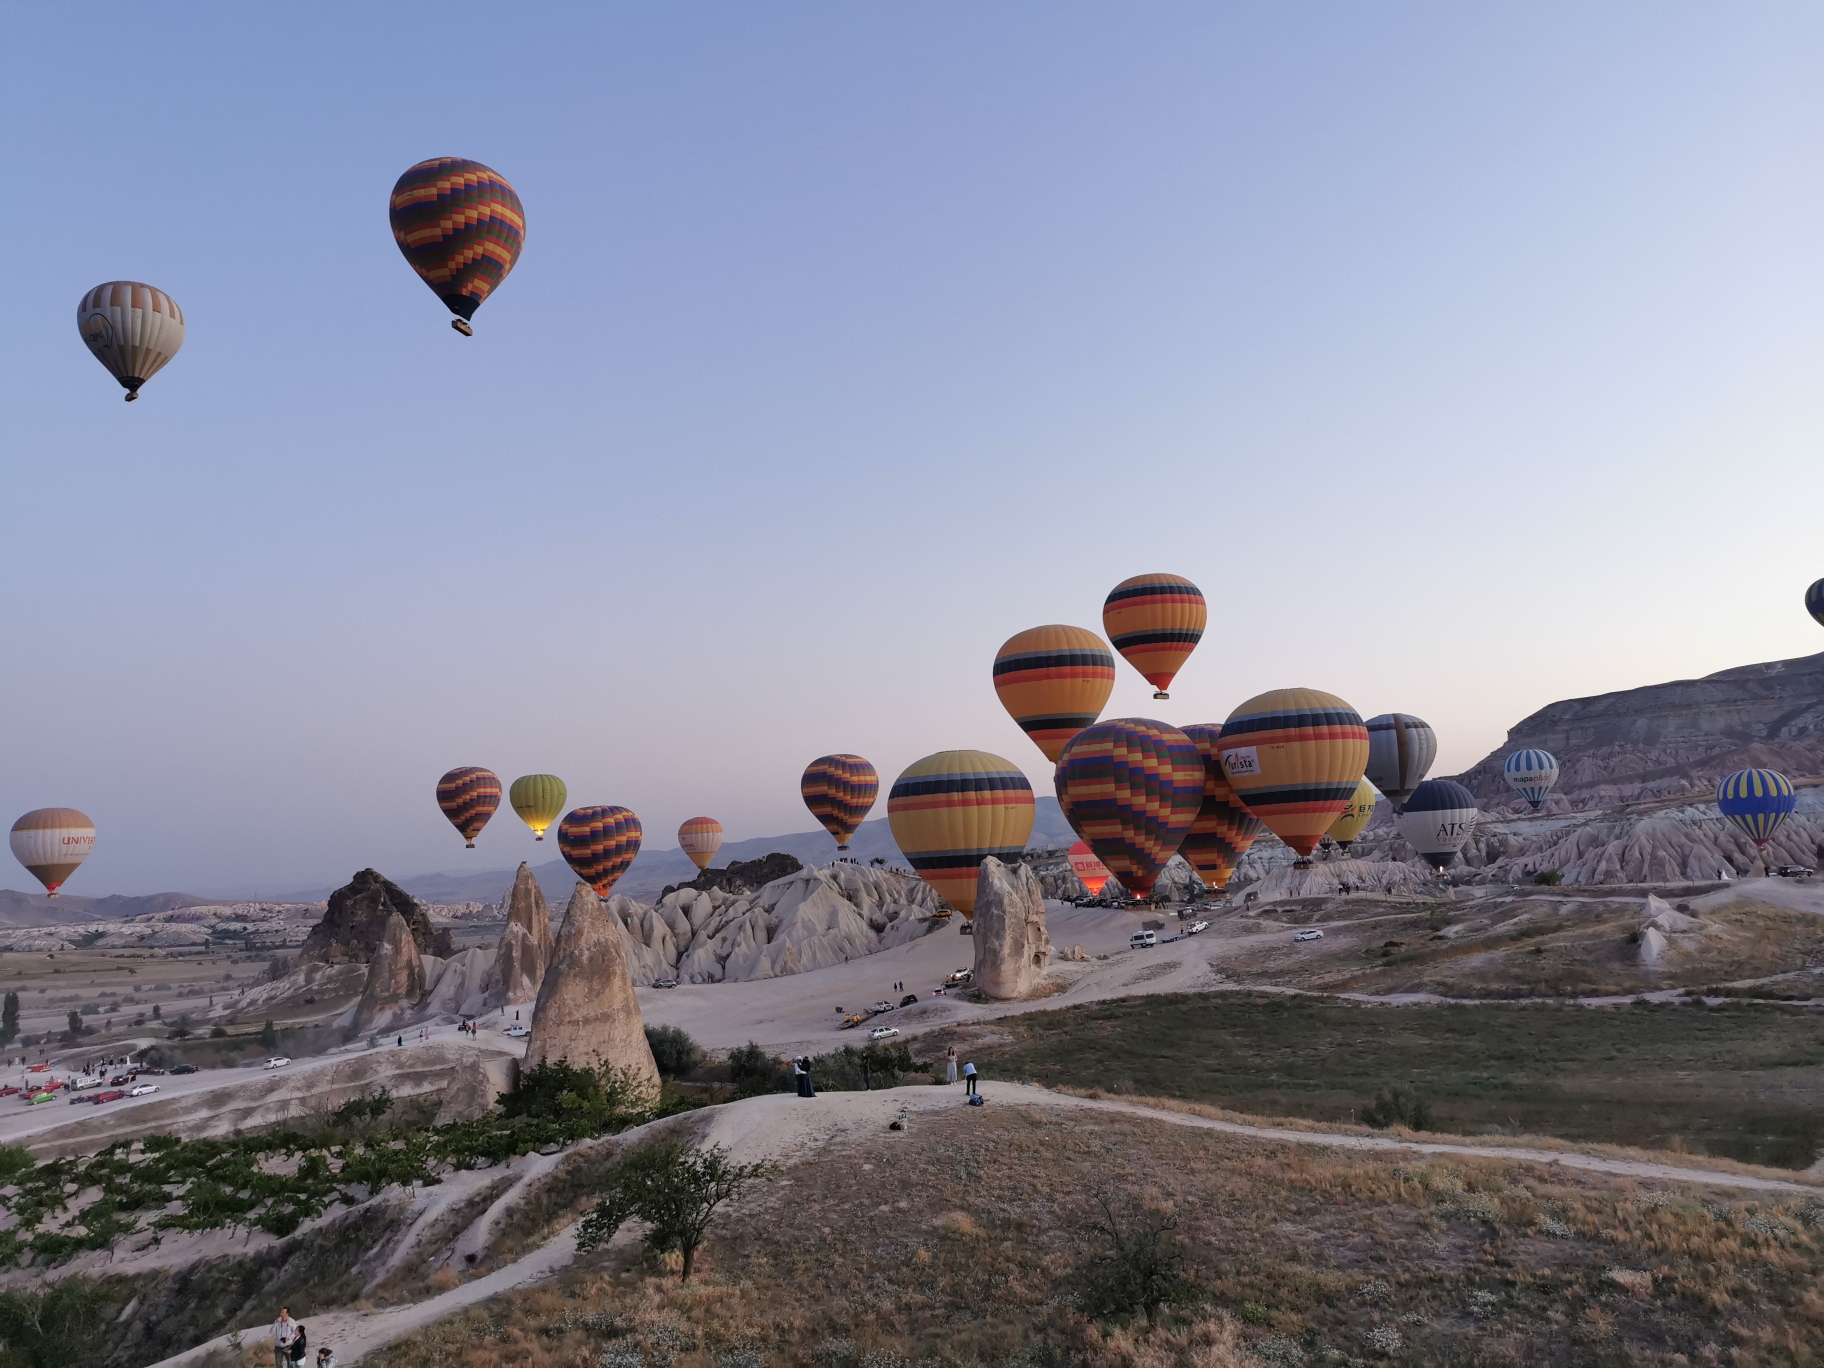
[0,4,1824,894]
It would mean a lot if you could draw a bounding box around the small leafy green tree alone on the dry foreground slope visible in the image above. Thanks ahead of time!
[576,1136,779,1282]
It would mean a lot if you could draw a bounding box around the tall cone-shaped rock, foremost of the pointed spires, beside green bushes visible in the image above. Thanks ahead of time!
[525,881,658,1089]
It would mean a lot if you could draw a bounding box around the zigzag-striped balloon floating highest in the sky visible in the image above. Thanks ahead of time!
[389,157,525,337]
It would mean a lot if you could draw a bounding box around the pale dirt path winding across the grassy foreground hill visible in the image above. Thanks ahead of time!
[153,1083,1824,1368]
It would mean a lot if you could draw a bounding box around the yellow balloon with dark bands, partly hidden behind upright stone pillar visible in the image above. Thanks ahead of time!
[886,750,1032,921]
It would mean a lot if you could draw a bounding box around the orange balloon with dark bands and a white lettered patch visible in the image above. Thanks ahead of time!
[1220,689,1368,859]
